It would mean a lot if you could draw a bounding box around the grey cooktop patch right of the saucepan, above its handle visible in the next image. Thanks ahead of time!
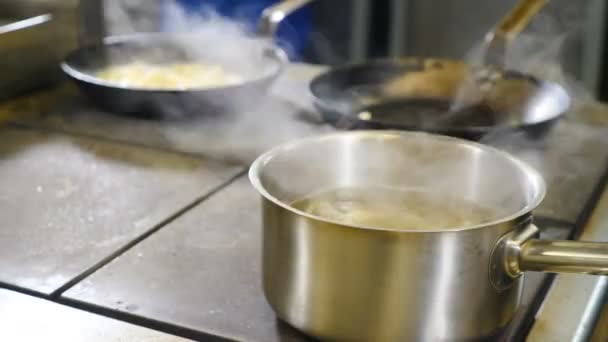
[487,120,608,223]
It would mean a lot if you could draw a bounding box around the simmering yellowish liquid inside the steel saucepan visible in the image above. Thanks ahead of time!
[291,187,498,230]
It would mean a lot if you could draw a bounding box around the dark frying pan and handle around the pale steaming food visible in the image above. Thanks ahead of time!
[61,0,311,118]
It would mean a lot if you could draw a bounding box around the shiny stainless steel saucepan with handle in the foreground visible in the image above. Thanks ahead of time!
[250,131,608,341]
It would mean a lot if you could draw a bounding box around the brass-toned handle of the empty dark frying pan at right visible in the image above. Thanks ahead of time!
[484,0,548,67]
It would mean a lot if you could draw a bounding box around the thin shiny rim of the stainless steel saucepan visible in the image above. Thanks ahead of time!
[249,130,546,233]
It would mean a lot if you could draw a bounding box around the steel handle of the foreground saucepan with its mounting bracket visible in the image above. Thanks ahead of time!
[490,224,608,287]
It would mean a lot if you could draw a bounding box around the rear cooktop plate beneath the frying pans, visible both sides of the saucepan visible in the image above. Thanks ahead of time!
[5,64,608,224]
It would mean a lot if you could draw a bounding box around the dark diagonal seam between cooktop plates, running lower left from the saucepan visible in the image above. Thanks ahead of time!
[49,170,247,299]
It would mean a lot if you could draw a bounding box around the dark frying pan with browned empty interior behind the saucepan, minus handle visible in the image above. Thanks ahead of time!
[311,58,570,139]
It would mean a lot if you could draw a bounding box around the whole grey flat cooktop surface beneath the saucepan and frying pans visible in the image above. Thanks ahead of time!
[0,65,608,341]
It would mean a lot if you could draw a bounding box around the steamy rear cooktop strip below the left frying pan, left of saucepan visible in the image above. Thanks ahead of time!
[5,64,331,165]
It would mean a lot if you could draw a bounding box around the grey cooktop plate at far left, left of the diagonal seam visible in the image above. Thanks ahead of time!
[0,128,241,293]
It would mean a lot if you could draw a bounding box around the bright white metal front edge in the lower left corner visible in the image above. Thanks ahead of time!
[0,289,189,342]
